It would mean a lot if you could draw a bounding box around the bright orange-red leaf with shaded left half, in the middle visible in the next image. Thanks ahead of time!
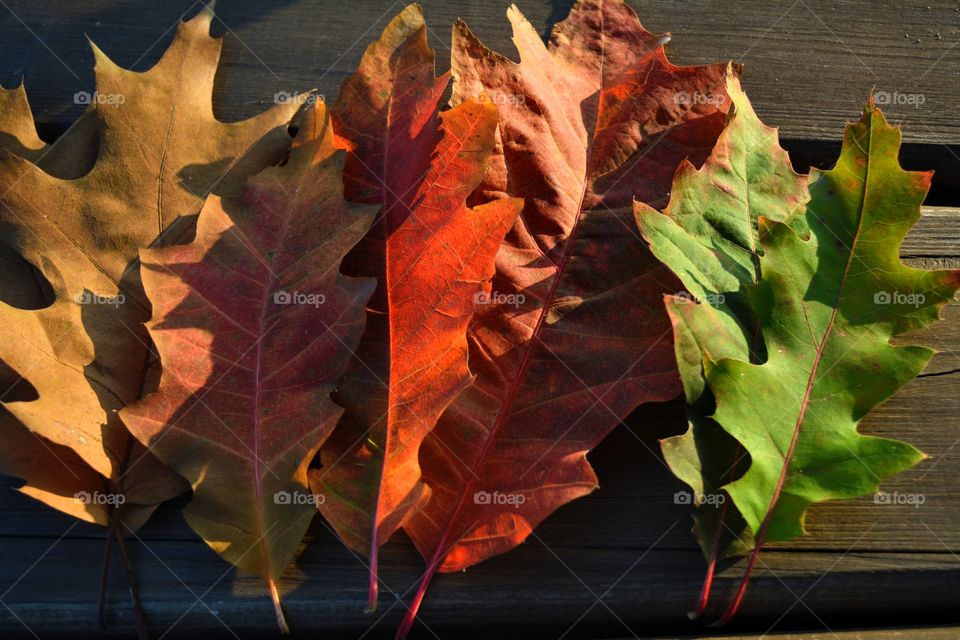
[311,5,521,610]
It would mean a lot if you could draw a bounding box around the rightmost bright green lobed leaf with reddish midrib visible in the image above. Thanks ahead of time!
[697,101,960,624]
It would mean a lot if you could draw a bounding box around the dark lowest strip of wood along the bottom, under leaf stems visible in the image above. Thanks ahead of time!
[0,536,960,638]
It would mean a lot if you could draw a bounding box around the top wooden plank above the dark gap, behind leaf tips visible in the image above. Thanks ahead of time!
[0,0,960,174]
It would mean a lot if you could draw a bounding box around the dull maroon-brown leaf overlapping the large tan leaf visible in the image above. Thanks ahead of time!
[121,102,375,630]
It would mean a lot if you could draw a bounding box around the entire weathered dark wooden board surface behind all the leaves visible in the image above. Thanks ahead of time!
[0,0,960,640]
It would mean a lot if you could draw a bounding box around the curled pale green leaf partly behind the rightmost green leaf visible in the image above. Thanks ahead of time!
[635,77,809,617]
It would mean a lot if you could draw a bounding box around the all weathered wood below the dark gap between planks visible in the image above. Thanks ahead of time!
[0,239,960,639]
